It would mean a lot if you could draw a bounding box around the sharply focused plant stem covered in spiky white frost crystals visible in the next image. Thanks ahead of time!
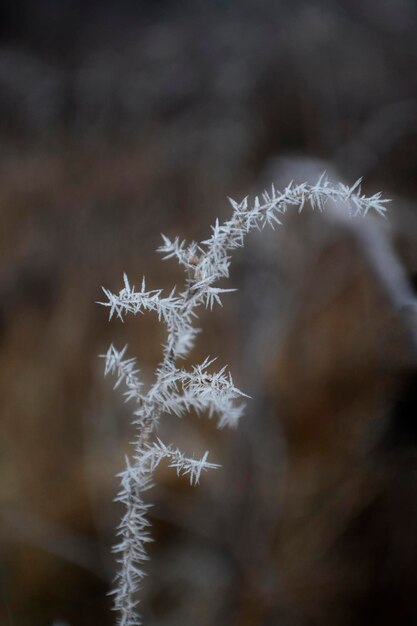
[101,175,388,626]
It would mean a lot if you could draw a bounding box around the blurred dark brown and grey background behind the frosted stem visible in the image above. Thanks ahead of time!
[0,0,417,626]
